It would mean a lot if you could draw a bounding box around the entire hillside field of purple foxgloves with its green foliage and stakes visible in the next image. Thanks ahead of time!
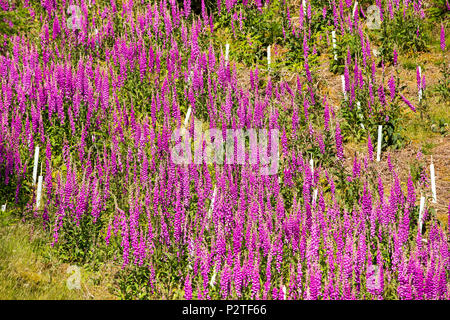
[0,0,450,299]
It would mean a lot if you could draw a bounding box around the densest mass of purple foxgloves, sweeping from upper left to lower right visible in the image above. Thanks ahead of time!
[0,0,450,299]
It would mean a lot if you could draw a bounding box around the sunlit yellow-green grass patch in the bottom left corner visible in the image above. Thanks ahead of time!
[0,212,113,300]
